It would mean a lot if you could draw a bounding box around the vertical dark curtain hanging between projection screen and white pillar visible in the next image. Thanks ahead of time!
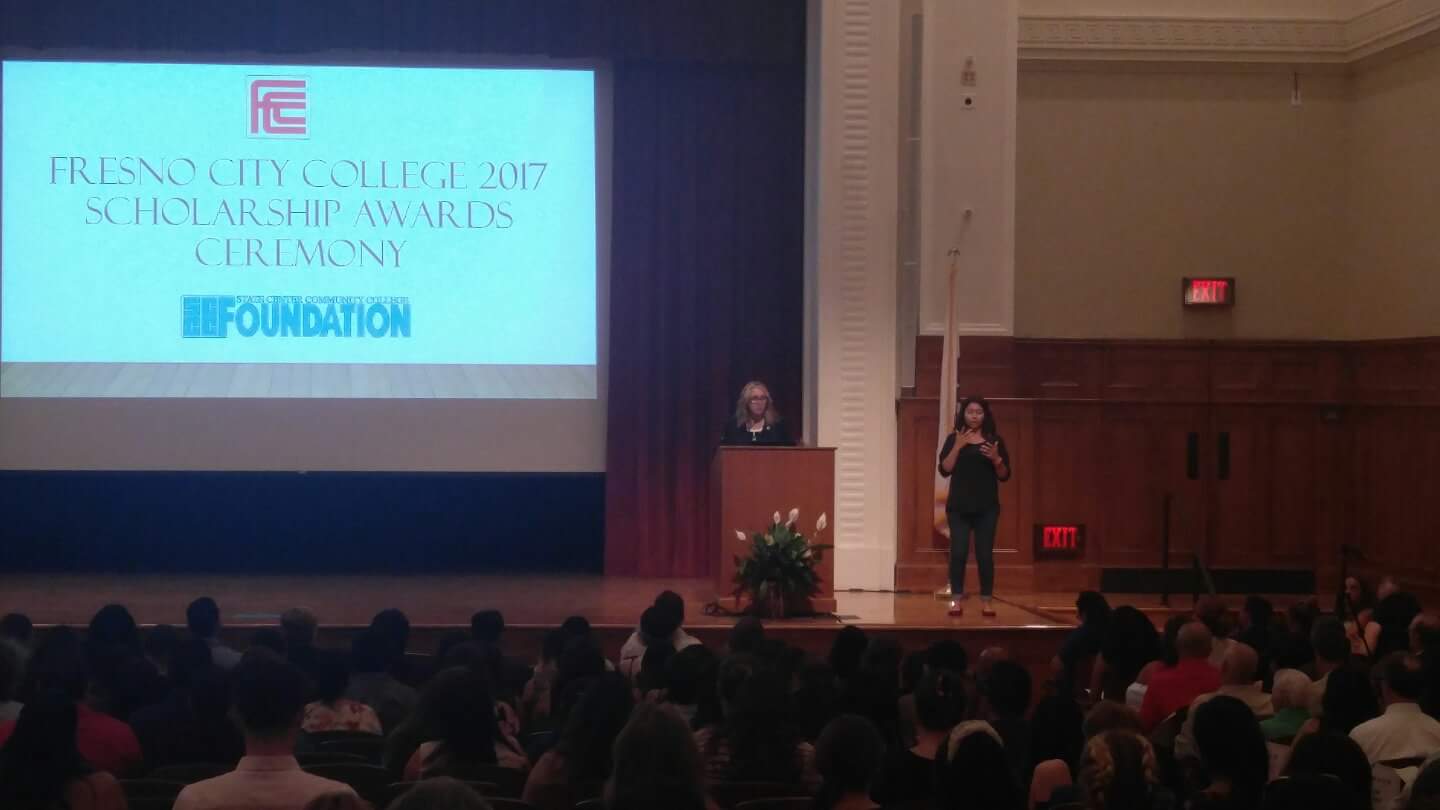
[605,64,805,577]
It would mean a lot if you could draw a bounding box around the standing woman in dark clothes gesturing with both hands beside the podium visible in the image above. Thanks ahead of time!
[940,396,1009,615]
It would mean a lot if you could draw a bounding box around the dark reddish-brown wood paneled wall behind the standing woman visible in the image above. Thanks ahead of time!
[896,337,1440,591]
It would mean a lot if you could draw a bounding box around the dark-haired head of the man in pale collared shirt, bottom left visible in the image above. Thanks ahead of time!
[230,650,310,752]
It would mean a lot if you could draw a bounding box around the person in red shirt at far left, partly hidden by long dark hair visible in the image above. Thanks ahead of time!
[0,628,141,777]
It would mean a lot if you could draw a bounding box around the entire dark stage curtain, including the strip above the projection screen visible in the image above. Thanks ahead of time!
[0,0,805,577]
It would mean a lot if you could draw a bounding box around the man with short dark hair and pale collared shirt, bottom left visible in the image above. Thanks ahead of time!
[174,650,354,810]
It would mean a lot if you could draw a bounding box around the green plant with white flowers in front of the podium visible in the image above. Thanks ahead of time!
[734,509,835,617]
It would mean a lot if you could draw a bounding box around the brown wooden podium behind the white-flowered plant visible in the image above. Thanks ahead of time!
[710,445,835,613]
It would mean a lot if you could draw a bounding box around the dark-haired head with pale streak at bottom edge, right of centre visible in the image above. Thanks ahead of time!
[935,721,1025,810]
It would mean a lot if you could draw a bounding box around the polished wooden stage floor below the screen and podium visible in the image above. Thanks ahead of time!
[0,574,1074,630]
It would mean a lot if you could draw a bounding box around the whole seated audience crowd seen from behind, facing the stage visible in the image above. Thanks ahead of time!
[0,579,1440,810]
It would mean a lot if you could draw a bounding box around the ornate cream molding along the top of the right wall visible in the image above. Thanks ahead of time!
[1020,0,1440,65]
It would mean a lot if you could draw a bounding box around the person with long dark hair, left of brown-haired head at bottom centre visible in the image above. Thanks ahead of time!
[521,673,635,810]
